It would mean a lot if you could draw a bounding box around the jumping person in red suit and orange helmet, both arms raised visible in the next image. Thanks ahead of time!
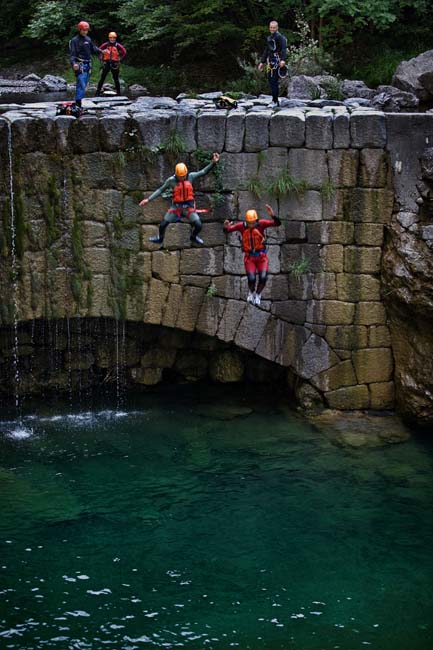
[224,205,281,306]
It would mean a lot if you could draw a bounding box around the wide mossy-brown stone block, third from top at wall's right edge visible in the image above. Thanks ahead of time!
[346,188,394,223]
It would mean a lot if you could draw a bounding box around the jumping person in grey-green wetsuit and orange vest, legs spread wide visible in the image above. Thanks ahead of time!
[140,152,220,244]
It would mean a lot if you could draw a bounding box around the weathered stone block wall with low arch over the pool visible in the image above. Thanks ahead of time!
[0,100,416,409]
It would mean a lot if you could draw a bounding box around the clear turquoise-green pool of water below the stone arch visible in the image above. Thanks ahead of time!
[0,387,433,650]
